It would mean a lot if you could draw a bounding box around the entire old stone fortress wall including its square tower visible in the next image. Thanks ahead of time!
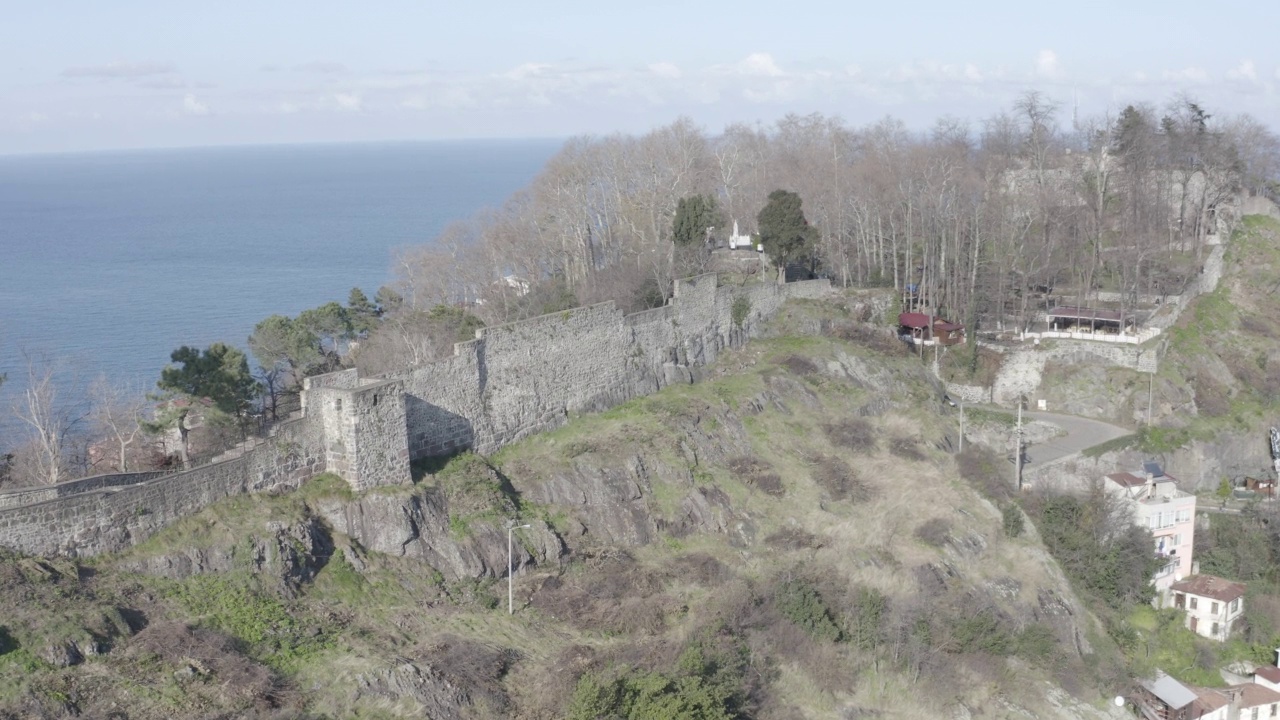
[0,275,831,556]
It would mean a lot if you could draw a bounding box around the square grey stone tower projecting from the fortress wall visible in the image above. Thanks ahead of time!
[302,370,411,491]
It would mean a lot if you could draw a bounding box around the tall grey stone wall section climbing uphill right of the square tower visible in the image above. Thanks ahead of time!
[390,275,831,459]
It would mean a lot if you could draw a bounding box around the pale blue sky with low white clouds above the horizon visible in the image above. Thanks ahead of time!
[0,0,1280,154]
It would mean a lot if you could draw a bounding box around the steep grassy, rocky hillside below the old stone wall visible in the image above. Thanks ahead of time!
[0,302,1121,719]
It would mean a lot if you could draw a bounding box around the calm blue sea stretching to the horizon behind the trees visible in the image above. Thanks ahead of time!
[0,140,561,451]
